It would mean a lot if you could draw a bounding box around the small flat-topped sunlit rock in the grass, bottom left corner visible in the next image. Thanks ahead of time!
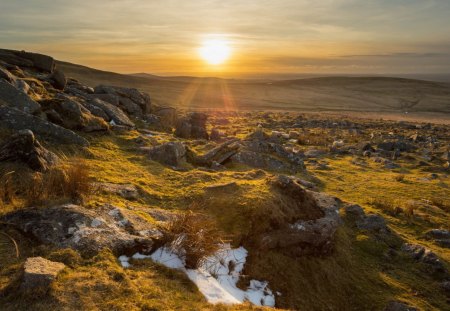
[20,257,66,295]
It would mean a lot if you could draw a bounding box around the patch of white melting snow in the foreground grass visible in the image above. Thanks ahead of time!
[119,244,275,307]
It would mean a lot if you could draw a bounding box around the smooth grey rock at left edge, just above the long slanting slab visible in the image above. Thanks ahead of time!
[0,80,41,114]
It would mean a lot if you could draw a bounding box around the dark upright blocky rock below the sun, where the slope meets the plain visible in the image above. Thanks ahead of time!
[175,112,209,139]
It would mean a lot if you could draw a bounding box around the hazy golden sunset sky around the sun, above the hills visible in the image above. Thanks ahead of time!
[0,0,450,77]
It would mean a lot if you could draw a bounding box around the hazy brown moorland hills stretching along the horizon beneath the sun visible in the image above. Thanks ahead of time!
[58,62,450,114]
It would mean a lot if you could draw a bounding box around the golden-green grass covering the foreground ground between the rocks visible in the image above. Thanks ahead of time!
[0,125,450,310]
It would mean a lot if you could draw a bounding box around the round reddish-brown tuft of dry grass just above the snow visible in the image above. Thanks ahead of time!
[165,211,223,268]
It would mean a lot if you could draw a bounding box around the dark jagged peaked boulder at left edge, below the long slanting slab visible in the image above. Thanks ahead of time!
[0,130,59,171]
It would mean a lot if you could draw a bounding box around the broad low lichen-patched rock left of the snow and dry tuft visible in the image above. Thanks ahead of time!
[1,204,160,257]
